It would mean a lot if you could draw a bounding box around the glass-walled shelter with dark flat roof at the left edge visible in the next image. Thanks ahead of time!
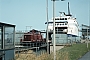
[0,22,15,60]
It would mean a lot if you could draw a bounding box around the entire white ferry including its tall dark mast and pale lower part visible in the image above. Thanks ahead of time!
[45,2,79,43]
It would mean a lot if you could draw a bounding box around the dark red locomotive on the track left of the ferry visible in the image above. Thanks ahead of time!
[20,29,45,43]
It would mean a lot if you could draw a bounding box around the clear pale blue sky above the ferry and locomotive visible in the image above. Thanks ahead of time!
[0,0,90,30]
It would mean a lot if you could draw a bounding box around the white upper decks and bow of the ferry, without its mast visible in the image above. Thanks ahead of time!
[45,12,78,36]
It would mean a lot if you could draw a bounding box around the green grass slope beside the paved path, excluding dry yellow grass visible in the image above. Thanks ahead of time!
[58,43,90,60]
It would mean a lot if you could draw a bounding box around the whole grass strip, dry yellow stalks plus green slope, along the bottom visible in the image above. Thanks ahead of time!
[16,43,90,60]
